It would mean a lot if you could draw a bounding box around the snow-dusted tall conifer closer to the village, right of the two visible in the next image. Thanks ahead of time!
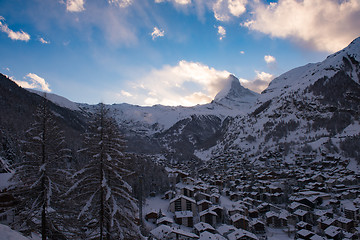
[68,104,141,240]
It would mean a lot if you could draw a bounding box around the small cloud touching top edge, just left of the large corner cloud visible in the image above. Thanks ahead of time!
[212,0,247,21]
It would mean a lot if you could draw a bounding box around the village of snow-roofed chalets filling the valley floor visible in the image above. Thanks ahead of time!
[143,152,360,240]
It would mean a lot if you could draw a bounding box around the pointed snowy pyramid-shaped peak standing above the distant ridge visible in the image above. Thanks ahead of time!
[214,74,258,103]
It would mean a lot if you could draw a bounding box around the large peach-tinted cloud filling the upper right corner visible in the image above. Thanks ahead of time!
[242,0,360,52]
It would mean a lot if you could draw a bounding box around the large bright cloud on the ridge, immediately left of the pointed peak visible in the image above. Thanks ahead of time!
[129,60,230,106]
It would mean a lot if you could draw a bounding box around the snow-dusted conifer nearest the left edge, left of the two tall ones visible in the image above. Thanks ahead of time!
[13,98,68,240]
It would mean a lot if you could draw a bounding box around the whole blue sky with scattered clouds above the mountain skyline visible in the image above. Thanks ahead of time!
[0,0,360,106]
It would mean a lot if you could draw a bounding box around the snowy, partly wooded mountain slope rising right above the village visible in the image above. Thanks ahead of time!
[201,38,360,166]
